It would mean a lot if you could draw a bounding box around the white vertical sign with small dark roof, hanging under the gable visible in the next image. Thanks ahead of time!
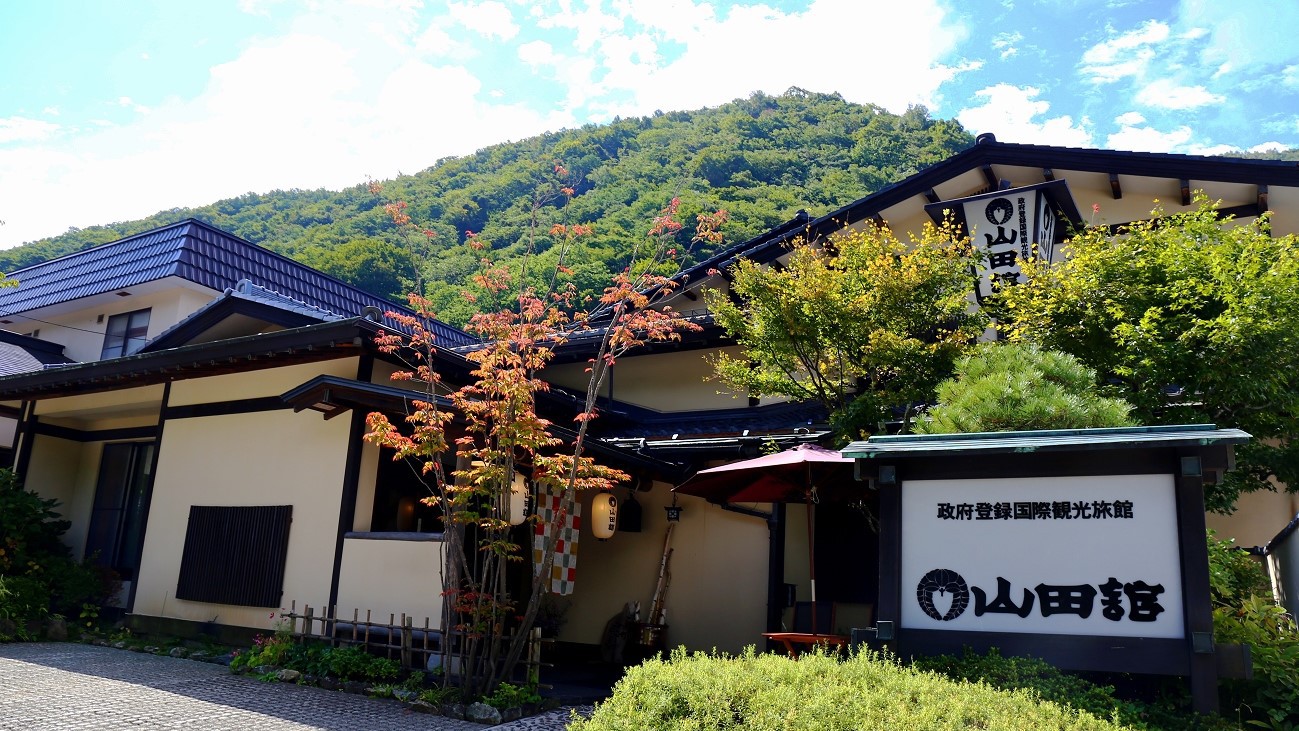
[925,180,1077,300]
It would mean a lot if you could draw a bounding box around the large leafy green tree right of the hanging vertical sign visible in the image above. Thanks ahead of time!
[1002,196,1299,512]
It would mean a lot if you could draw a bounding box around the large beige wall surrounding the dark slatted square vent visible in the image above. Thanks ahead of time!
[134,410,351,627]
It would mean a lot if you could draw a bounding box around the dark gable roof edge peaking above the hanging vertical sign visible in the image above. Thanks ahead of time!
[675,134,1299,283]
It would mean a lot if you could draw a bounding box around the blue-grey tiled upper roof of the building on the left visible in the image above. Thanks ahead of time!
[0,218,474,345]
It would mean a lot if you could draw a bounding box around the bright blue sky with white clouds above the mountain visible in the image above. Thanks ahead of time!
[0,0,1299,247]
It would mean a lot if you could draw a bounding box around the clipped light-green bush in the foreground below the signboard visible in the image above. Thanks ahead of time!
[569,648,1124,731]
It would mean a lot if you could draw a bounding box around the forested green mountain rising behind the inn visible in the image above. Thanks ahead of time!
[0,88,973,322]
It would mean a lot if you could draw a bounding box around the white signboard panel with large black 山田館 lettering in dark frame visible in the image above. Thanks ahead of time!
[900,475,1185,638]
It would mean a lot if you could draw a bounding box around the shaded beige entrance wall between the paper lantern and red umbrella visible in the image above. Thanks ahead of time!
[560,483,768,652]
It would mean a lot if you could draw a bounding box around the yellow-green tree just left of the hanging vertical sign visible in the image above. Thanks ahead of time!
[707,216,986,439]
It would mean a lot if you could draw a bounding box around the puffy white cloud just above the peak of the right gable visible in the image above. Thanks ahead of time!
[956,83,1092,147]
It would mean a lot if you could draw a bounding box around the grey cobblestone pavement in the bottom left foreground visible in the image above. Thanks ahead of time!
[0,643,589,731]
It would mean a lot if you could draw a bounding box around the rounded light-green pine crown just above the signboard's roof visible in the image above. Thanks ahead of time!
[916,343,1134,434]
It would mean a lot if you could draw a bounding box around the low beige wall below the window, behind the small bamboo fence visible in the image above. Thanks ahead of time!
[335,538,442,627]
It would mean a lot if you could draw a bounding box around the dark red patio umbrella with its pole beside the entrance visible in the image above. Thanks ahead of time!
[673,444,852,634]
